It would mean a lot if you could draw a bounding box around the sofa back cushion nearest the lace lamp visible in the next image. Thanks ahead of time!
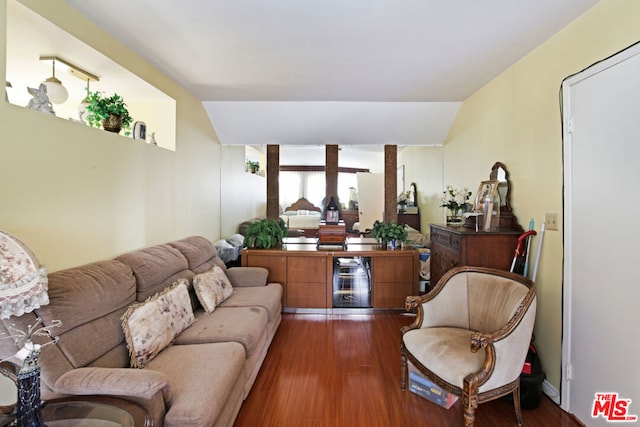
[36,260,136,370]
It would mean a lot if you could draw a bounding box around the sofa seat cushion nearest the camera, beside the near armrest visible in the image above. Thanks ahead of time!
[145,342,245,427]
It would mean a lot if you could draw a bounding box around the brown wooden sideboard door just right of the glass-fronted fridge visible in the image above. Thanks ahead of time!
[371,252,418,308]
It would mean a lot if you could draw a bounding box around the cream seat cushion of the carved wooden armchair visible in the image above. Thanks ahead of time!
[402,327,485,388]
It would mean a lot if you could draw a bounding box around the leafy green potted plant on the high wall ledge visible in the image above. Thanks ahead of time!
[84,91,133,135]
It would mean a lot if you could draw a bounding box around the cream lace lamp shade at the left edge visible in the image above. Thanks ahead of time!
[0,231,49,319]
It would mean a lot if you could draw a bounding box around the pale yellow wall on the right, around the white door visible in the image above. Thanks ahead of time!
[444,0,640,389]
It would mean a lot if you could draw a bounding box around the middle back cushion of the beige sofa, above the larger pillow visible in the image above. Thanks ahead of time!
[116,244,194,301]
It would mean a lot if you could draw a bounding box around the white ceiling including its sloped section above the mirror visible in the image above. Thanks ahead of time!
[66,0,597,145]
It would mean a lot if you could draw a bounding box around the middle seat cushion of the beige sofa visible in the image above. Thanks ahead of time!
[174,307,267,357]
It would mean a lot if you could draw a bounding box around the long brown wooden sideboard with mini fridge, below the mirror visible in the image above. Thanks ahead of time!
[242,238,420,310]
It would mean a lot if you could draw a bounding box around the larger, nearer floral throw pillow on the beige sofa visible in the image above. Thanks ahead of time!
[122,279,194,368]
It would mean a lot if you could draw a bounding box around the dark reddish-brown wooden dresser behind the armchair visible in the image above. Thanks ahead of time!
[429,224,522,286]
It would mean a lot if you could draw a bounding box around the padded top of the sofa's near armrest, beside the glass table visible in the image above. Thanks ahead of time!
[54,368,171,402]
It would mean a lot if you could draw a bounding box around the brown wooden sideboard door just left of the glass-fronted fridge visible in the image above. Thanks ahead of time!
[287,256,327,308]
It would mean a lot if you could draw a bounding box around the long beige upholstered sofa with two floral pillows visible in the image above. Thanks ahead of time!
[3,236,282,427]
